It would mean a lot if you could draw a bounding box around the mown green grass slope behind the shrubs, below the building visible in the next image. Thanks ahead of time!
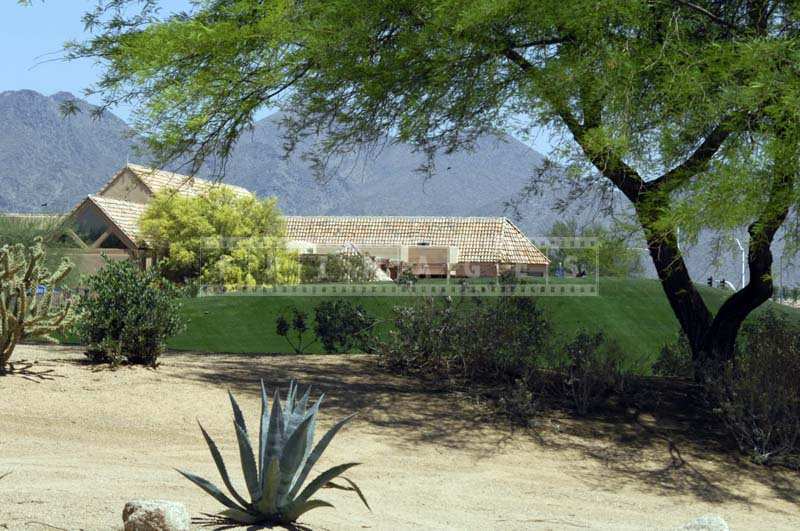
[169,279,800,359]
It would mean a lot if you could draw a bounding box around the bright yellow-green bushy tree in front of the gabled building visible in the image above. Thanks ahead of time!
[140,187,300,288]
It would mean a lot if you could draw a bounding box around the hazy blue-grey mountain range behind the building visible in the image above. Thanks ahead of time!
[0,90,800,283]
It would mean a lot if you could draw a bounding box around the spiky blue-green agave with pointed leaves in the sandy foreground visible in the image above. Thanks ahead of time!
[178,380,369,525]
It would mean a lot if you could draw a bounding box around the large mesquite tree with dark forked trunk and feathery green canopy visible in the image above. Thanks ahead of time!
[56,0,800,380]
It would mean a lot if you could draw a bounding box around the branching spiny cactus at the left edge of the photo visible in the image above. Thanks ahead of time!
[0,238,72,374]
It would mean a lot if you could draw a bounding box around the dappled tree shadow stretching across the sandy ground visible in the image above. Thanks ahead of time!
[155,353,800,510]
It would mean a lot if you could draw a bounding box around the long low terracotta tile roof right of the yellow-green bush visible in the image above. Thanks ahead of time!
[286,216,549,264]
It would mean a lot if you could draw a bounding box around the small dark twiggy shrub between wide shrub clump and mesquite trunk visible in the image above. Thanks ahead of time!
[560,331,625,415]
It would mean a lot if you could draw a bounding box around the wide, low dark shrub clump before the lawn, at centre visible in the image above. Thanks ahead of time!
[380,297,551,385]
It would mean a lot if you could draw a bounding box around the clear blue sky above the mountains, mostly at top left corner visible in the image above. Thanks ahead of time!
[0,0,551,153]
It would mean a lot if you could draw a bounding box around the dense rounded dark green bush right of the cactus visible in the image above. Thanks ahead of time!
[76,260,183,366]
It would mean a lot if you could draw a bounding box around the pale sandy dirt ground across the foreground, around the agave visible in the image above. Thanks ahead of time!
[0,346,800,530]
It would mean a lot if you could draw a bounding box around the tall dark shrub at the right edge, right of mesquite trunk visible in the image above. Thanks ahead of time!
[713,312,800,466]
